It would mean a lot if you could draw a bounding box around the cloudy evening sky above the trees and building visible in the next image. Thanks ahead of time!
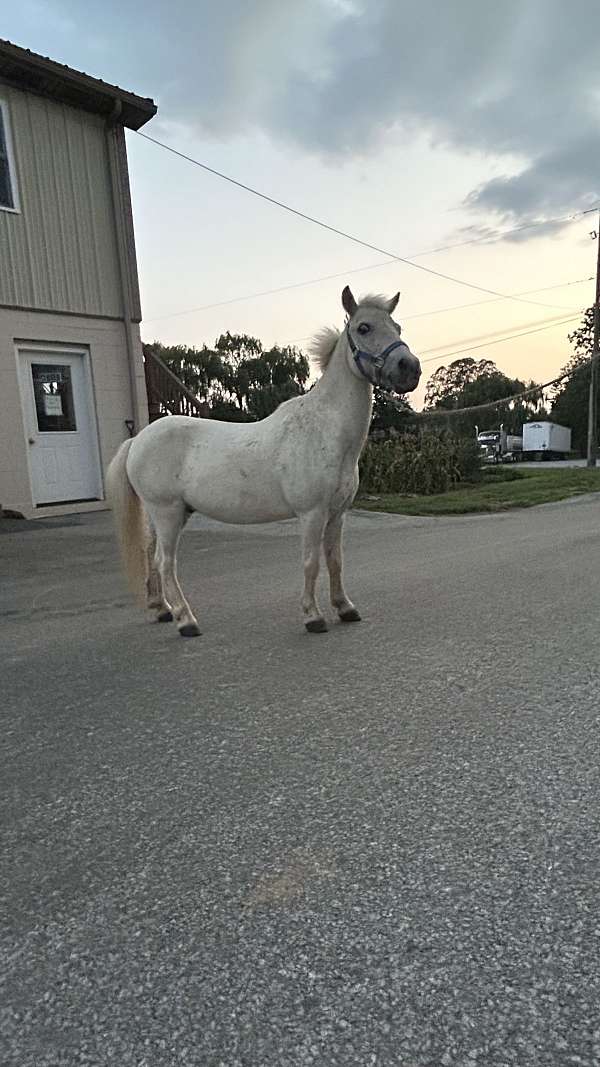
[0,0,600,407]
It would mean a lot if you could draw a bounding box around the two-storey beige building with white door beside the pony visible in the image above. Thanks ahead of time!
[0,42,156,517]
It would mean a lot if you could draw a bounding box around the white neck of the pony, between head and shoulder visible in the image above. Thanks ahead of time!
[314,334,373,446]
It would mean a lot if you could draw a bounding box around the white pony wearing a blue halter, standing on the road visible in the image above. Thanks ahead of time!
[107,286,421,637]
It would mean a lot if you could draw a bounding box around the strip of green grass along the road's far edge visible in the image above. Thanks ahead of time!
[356,467,600,515]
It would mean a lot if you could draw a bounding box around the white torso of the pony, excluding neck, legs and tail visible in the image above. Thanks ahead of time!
[127,394,356,523]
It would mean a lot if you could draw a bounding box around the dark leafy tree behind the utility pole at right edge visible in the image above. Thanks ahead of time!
[551,307,600,453]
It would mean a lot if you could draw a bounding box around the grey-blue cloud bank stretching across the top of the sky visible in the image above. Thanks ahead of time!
[24,0,600,224]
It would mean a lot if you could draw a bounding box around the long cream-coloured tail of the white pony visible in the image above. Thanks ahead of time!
[106,439,147,598]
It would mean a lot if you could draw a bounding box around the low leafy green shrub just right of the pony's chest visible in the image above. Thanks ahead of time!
[360,433,481,496]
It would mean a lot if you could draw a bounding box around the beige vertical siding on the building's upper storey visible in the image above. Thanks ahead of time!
[0,81,123,318]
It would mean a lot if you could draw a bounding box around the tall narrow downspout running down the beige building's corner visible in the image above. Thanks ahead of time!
[106,99,144,433]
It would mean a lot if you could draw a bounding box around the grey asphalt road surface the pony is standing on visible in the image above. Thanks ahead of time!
[0,497,600,1067]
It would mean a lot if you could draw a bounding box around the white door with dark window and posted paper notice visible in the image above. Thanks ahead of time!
[19,349,101,505]
